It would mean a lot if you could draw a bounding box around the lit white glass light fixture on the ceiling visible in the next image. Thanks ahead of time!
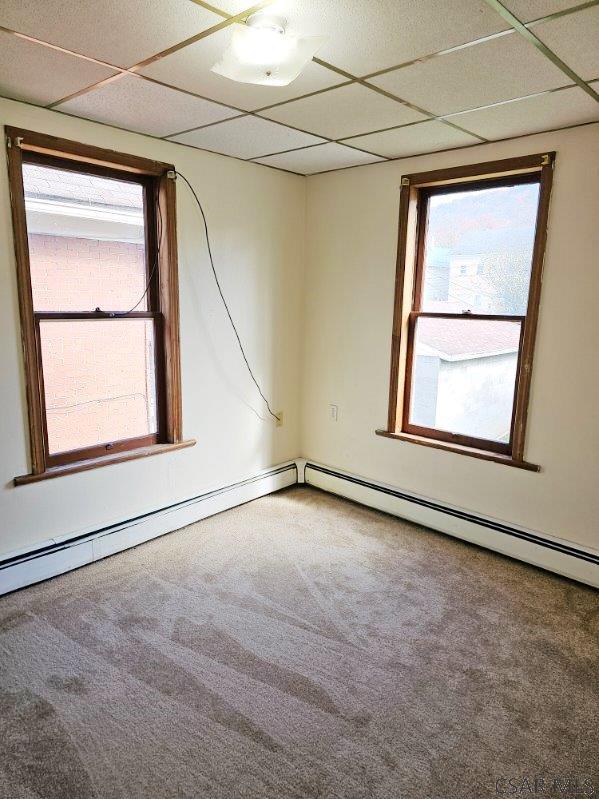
[212,11,325,86]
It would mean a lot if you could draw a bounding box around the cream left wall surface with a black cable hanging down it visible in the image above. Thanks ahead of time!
[0,100,305,557]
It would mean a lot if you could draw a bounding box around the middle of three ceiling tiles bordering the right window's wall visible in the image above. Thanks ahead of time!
[348,120,479,158]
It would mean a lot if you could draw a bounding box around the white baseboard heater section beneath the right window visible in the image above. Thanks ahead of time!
[304,461,599,587]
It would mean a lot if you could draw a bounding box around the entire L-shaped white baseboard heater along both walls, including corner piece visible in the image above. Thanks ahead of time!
[0,459,599,595]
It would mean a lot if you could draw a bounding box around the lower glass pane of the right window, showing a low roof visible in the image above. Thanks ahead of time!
[410,317,520,443]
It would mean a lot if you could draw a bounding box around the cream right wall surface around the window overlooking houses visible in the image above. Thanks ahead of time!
[302,125,599,547]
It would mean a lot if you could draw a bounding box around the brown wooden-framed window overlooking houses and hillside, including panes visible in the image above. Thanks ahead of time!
[377,153,554,470]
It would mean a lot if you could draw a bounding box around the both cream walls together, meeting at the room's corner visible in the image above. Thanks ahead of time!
[0,100,599,557]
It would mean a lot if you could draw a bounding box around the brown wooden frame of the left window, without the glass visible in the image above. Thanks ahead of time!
[5,126,195,485]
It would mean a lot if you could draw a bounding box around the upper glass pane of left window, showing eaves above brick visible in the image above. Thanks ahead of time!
[23,164,148,311]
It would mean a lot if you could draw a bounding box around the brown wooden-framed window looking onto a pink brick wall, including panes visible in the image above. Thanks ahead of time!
[6,128,193,483]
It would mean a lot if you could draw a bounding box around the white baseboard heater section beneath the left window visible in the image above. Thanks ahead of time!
[0,461,297,595]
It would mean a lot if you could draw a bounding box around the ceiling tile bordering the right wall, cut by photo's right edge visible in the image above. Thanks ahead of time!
[451,87,599,139]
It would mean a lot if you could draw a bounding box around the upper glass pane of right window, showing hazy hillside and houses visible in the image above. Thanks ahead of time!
[421,183,539,316]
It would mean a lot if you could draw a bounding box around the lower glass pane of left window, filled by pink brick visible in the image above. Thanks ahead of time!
[40,319,158,454]
